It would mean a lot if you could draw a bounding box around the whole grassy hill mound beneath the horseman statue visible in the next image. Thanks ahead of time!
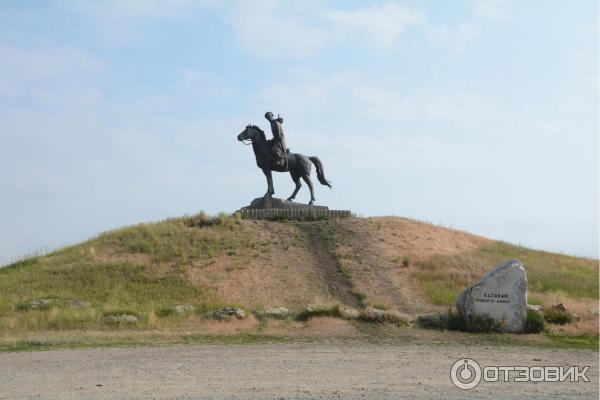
[0,213,598,349]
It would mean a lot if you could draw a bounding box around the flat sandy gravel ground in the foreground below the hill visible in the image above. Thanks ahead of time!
[0,343,598,399]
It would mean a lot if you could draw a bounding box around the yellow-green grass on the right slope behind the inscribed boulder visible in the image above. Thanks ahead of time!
[410,242,598,337]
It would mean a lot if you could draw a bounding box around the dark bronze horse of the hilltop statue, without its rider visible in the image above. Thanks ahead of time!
[238,125,332,204]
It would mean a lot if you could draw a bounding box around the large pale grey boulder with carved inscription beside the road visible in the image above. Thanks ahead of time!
[456,260,527,333]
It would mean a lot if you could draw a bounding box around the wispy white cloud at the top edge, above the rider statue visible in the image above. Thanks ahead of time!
[229,0,424,58]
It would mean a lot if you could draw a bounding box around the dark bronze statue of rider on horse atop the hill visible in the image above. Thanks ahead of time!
[238,111,332,205]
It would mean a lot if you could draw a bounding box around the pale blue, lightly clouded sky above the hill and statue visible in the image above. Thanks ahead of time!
[0,0,599,264]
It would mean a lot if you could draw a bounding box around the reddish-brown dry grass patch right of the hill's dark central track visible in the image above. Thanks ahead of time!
[312,217,491,315]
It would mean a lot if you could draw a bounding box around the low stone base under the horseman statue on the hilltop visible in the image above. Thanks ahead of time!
[238,197,352,220]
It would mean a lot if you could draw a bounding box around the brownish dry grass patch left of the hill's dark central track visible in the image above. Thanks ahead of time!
[187,221,342,309]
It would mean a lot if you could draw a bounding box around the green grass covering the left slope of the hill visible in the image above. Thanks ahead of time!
[0,214,253,335]
